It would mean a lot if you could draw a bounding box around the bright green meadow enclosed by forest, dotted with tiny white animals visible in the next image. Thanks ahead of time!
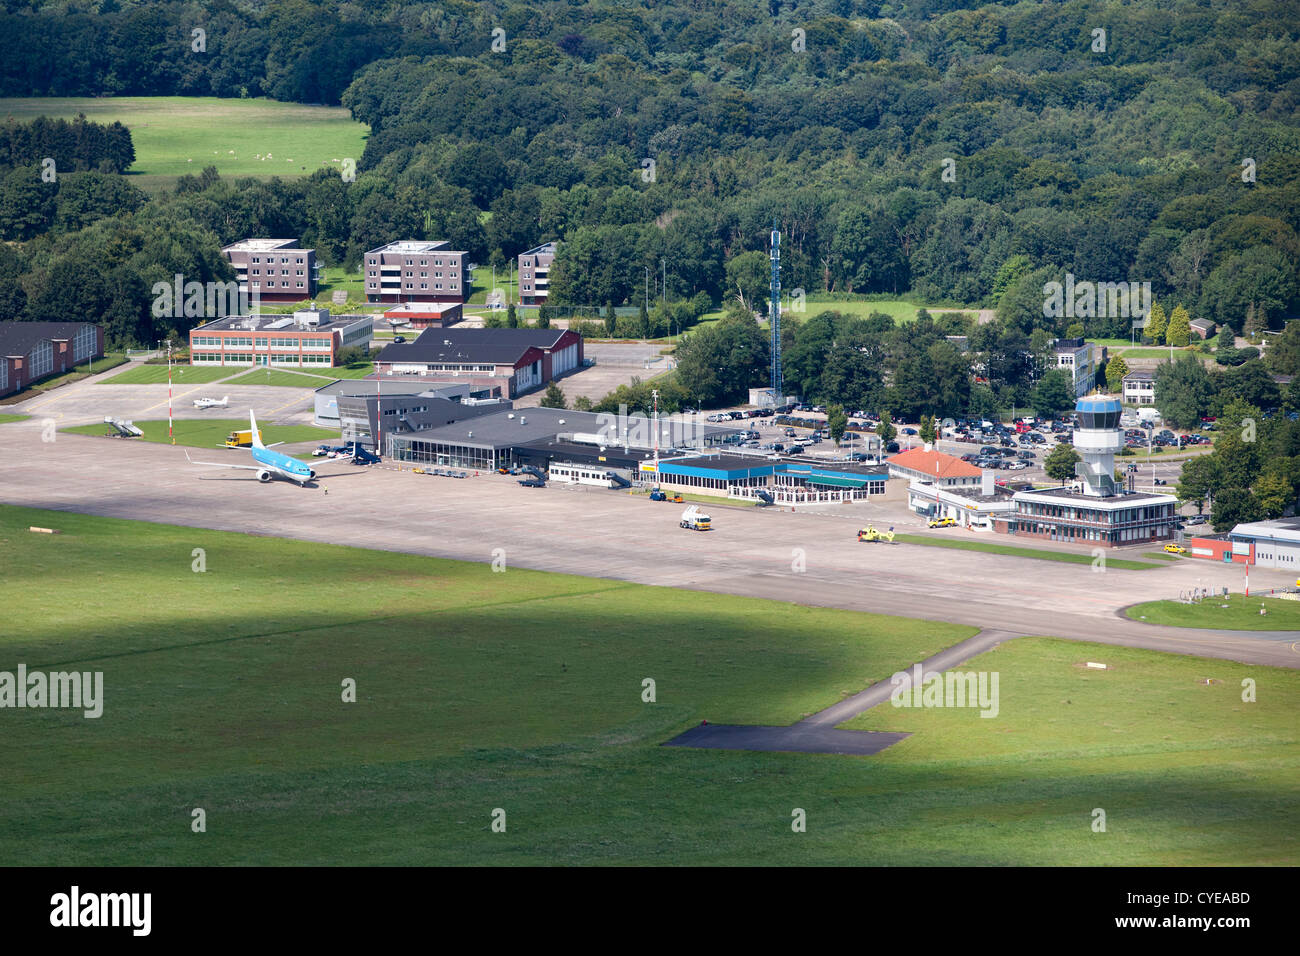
[0,96,369,191]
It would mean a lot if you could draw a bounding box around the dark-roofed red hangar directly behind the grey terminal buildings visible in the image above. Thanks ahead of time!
[374,328,582,398]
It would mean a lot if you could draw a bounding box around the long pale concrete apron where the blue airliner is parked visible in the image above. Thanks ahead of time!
[0,418,1300,667]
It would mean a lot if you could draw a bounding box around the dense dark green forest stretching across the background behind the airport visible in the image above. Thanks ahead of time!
[0,0,1300,374]
